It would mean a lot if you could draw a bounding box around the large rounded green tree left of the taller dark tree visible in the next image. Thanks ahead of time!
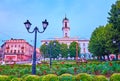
[88,24,113,60]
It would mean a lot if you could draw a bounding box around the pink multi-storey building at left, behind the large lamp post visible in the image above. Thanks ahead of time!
[1,39,40,62]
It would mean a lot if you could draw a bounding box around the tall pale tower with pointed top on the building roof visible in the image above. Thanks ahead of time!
[62,16,70,38]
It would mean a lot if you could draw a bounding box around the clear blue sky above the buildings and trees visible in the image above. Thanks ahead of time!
[0,0,116,47]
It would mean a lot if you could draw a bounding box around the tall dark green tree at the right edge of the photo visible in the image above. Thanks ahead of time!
[108,0,120,60]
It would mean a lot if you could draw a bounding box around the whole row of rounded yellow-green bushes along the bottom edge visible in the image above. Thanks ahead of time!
[0,73,120,81]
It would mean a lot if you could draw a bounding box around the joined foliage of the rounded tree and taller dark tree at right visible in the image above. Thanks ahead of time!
[88,1,120,60]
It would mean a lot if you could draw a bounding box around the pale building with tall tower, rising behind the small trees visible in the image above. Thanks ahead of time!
[41,17,91,59]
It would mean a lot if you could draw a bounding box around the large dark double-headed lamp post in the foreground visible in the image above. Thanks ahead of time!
[24,19,48,75]
